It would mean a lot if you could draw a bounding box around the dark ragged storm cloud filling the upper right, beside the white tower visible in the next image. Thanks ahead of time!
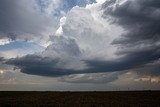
[102,0,160,75]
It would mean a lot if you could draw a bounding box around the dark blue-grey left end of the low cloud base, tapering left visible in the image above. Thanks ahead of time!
[6,55,75,76]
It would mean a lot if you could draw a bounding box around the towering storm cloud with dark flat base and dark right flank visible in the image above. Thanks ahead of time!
[4,0,160,76]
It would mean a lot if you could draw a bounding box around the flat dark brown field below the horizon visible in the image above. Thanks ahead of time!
[0,91,160,107]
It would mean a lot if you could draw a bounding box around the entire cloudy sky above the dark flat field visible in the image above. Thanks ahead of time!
[0,0,160,91]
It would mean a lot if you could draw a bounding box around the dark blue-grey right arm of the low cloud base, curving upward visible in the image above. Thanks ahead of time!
[88,48,160,72]
